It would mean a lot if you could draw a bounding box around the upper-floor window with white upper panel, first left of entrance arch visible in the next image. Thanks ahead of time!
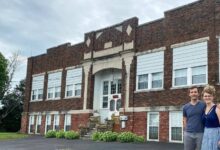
[65,68,82,97]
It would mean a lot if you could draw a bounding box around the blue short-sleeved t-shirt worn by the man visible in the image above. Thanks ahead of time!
[183,101,206,133]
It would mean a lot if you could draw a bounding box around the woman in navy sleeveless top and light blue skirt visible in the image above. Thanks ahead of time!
[202,85,220,150]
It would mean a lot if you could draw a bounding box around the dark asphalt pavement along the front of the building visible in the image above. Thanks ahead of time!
[0,136,183,150]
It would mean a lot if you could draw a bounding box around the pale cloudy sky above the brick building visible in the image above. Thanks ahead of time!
[0,0,197,85]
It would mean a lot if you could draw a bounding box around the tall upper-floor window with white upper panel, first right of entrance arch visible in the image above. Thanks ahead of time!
[136,51,164,90]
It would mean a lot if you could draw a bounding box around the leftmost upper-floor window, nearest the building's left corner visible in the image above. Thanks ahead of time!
[31,75,44,101]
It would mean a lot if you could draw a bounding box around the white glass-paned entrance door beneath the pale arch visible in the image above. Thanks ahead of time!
[100,79,121,123]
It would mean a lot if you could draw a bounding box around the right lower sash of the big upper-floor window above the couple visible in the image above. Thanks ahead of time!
[192,66,206,84]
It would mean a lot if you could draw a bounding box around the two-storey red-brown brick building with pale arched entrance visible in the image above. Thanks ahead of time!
[21,0,220,142]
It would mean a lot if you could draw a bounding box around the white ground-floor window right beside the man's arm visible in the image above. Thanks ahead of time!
[169,111,183,142]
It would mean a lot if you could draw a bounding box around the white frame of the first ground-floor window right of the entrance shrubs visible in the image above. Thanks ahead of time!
[147,112,160,142]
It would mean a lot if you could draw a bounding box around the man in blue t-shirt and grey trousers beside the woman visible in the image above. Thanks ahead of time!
[183,86,205,150]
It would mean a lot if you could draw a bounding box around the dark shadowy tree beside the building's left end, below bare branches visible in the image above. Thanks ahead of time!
[0,80,25,132]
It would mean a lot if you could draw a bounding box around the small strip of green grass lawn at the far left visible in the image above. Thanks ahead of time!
[0,132,28,141]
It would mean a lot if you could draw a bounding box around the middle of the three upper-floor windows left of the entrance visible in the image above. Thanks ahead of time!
[47,72,62,99]
